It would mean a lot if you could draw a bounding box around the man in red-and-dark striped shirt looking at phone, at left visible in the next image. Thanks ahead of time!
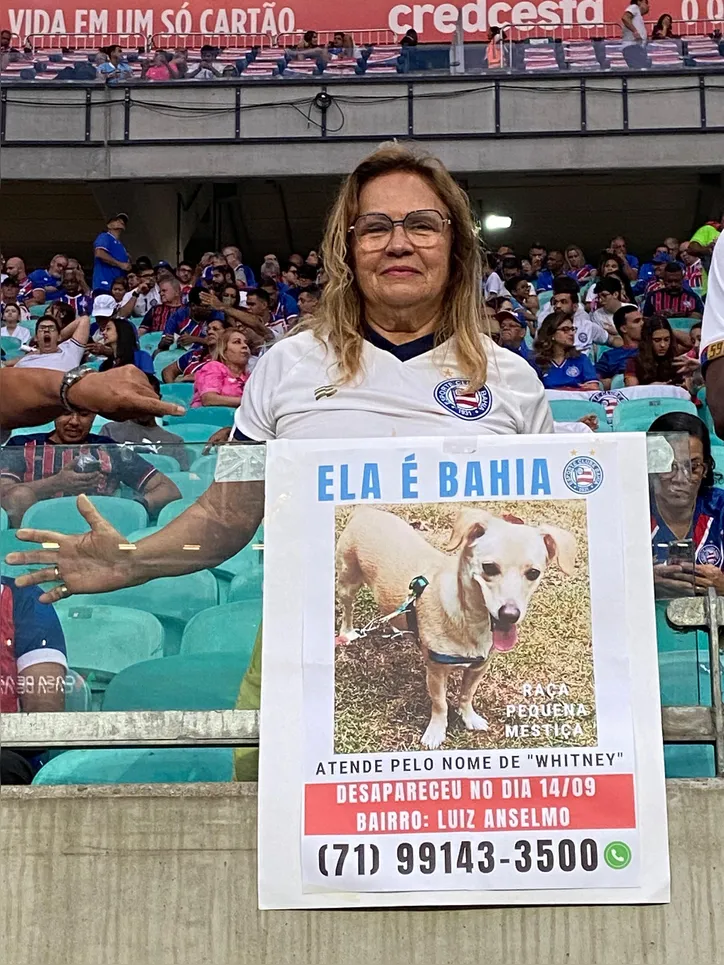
[0,411,181,527]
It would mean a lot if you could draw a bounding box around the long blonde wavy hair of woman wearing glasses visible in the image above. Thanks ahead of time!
[304,144,488,390]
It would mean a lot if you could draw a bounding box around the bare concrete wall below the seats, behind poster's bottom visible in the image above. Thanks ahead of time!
[0,781,724,965]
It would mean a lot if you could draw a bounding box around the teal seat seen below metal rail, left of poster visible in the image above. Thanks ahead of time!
[33,747,233,785]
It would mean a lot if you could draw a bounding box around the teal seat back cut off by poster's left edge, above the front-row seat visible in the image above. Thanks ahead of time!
[180,598,261,664]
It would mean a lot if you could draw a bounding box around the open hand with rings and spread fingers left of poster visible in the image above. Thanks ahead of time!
[6,495,133,603]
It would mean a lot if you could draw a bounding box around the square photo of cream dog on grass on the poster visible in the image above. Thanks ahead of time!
[334,499,596,754]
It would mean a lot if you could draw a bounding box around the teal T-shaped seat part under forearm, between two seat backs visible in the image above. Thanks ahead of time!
[63,572,219,656]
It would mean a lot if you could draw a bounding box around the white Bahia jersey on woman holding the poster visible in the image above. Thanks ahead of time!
[234,332,553,441]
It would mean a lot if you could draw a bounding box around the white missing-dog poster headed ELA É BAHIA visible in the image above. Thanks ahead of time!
[259,434,669,908]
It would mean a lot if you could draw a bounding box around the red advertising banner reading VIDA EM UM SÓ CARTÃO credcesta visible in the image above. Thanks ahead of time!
[7,0,724,46]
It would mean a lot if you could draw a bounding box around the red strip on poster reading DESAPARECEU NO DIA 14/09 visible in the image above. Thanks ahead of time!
[304,774,636,835]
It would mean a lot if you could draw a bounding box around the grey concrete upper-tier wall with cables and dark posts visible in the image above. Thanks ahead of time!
[3,74,724,181]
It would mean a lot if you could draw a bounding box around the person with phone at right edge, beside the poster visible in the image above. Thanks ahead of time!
[648,412,724,597]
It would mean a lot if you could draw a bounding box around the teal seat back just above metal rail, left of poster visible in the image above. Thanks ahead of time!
[103,652,248,710]
